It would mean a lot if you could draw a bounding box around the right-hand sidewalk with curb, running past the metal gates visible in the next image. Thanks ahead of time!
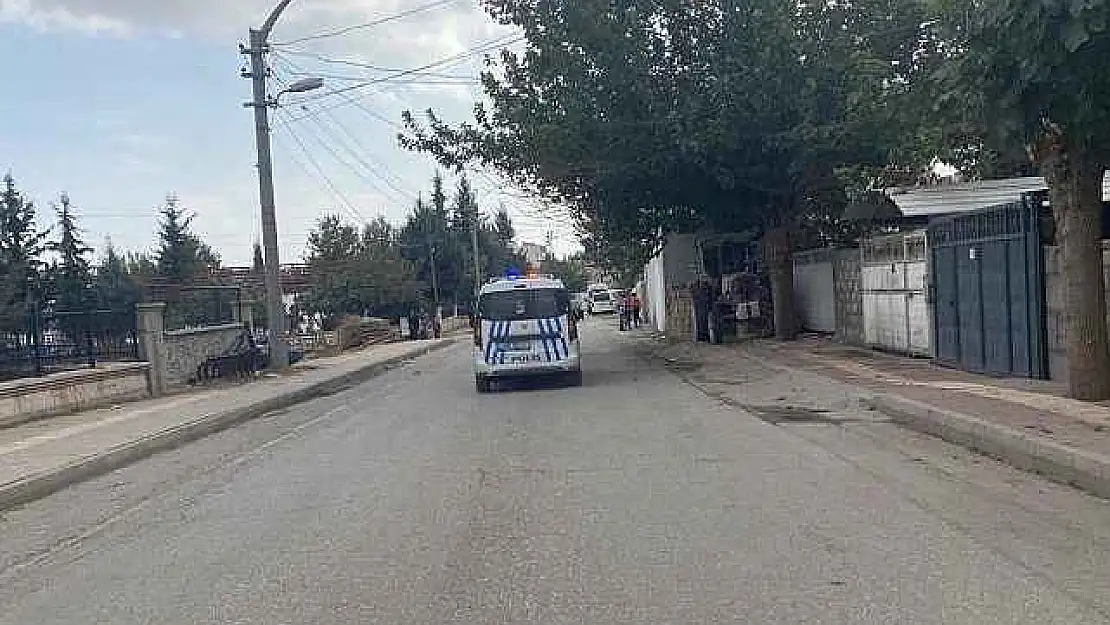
[654,336,1110,497]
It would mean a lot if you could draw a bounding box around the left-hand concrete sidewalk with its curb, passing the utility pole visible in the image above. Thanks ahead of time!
[0,339,454,511]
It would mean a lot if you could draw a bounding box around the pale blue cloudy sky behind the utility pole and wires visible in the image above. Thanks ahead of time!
[0,0,577,265]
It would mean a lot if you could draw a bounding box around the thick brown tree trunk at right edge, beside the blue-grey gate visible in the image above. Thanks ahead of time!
[1042,144,1110,401]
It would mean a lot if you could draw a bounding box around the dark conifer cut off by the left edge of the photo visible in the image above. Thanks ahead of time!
[0,173,49,330]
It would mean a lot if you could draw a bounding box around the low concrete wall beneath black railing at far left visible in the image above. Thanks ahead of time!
[0,362,150,427]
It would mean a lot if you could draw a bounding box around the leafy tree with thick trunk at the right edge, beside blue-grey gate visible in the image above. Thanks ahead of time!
[930,0,1110,400]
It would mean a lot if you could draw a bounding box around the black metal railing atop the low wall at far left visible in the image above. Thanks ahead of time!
[0,309,139,380]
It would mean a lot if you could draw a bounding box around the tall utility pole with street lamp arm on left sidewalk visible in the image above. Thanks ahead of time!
[240,0,324,371]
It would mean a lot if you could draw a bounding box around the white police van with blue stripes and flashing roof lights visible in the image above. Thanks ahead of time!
[474,275,582,393]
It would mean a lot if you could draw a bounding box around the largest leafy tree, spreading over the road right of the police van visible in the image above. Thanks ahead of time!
[401,0,929,336]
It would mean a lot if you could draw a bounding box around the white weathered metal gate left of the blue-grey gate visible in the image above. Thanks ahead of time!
[860,230,932,356]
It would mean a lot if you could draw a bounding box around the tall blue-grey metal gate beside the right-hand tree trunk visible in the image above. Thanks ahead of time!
[929,193,1048,379]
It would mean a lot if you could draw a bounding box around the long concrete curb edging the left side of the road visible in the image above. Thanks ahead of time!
[0,339,455,512]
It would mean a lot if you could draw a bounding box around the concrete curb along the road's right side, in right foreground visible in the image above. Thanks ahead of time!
[862,394,1110,498]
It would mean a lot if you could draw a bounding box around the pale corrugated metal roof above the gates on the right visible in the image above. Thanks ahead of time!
[887,175,1110,216]
